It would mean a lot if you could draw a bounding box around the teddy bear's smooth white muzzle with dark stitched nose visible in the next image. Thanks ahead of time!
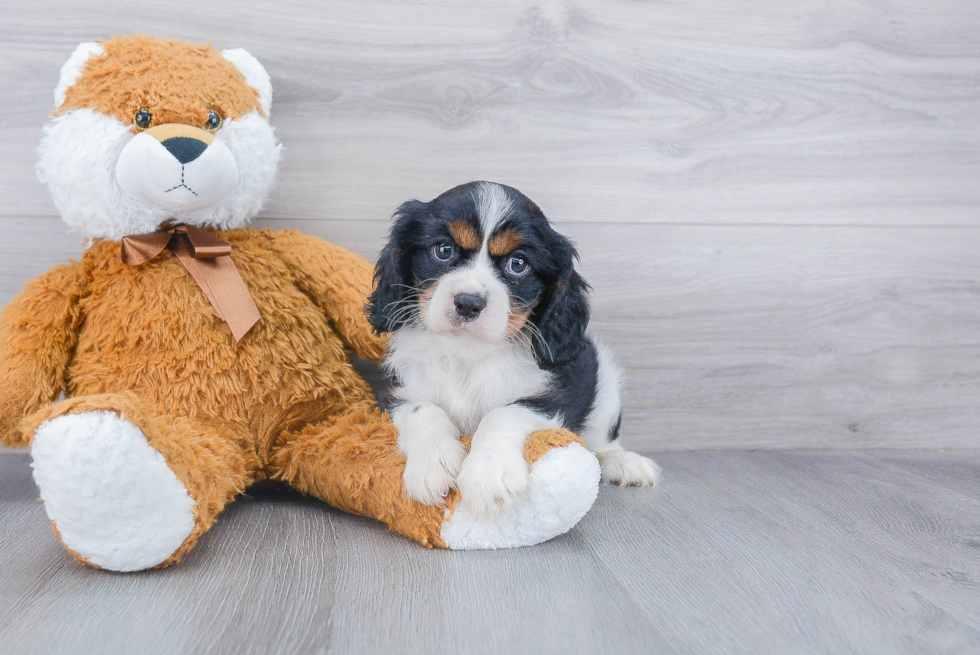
[116,123,238,213]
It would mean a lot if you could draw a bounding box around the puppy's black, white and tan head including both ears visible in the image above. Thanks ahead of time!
[368,182,589,364]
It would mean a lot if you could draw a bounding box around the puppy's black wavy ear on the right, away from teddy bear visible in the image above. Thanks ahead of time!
[532,235,590,365]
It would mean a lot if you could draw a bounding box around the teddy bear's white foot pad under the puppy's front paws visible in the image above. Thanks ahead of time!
[440,443,600,550]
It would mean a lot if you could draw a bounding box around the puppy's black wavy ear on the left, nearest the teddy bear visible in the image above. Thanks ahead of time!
[364,200,426,335]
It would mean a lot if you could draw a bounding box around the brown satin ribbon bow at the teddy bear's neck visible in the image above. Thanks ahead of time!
[119,223,259,341]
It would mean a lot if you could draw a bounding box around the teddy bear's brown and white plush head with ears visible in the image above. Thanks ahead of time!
[38,36,281,239]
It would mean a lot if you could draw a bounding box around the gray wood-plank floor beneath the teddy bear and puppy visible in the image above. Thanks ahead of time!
[0,451,980,655]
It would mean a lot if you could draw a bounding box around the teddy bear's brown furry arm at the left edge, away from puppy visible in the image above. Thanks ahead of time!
[0,262,83,447]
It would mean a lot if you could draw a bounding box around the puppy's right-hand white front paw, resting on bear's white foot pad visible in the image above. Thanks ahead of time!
[456,449,528,519]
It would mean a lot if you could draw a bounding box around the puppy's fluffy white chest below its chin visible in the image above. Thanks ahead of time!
[387,331,548,435]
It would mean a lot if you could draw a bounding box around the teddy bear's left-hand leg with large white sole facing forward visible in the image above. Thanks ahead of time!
[24,394,258,571]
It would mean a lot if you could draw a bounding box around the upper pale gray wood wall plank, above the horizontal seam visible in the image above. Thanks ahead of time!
[0,0,980,226]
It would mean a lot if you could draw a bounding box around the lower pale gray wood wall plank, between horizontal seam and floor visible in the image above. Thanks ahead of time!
[0,219,980,450]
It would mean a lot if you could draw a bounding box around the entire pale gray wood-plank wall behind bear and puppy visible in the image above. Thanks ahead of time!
[0,0,980,449]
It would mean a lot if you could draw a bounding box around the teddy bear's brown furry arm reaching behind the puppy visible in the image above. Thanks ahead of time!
[273,230,388,362]
